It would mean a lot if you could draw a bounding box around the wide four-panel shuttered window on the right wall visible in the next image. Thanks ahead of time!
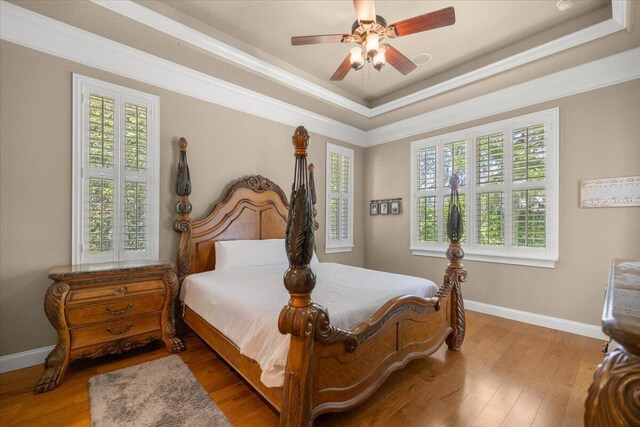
[411,108,559,267]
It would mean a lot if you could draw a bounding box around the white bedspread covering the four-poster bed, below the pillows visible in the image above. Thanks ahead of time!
[180,263,438,387]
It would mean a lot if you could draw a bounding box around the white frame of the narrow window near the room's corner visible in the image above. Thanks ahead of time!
[324,142,355,254]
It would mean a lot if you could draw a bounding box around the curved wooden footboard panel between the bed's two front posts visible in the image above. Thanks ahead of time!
[311,297,453,418]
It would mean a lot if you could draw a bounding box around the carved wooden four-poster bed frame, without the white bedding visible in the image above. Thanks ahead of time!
[174,127,467,426]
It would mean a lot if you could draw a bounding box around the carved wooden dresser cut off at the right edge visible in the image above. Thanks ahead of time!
[584,260,640,427]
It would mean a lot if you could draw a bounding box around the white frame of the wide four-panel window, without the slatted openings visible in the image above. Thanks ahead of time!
[409,108,560,268]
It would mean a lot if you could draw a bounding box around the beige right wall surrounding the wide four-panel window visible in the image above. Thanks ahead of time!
[364,80,640,325]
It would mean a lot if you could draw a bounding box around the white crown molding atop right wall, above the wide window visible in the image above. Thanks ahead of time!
[366,48,640,147]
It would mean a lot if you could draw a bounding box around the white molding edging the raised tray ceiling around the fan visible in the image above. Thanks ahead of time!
[90,0,628,118]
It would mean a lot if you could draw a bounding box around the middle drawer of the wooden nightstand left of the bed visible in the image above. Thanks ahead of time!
[67,292,165,327]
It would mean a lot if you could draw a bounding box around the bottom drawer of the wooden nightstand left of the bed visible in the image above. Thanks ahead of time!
[70,314,160,348]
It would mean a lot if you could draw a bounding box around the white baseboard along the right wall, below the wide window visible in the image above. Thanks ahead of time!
[464,300,609,340]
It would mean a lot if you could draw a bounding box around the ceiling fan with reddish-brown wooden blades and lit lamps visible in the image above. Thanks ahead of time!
[291,0,456,80]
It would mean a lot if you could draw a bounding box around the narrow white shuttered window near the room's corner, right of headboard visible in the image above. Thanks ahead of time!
[324,143,353,253]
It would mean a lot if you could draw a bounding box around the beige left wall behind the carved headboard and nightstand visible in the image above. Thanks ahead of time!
[0,42,364,355]
